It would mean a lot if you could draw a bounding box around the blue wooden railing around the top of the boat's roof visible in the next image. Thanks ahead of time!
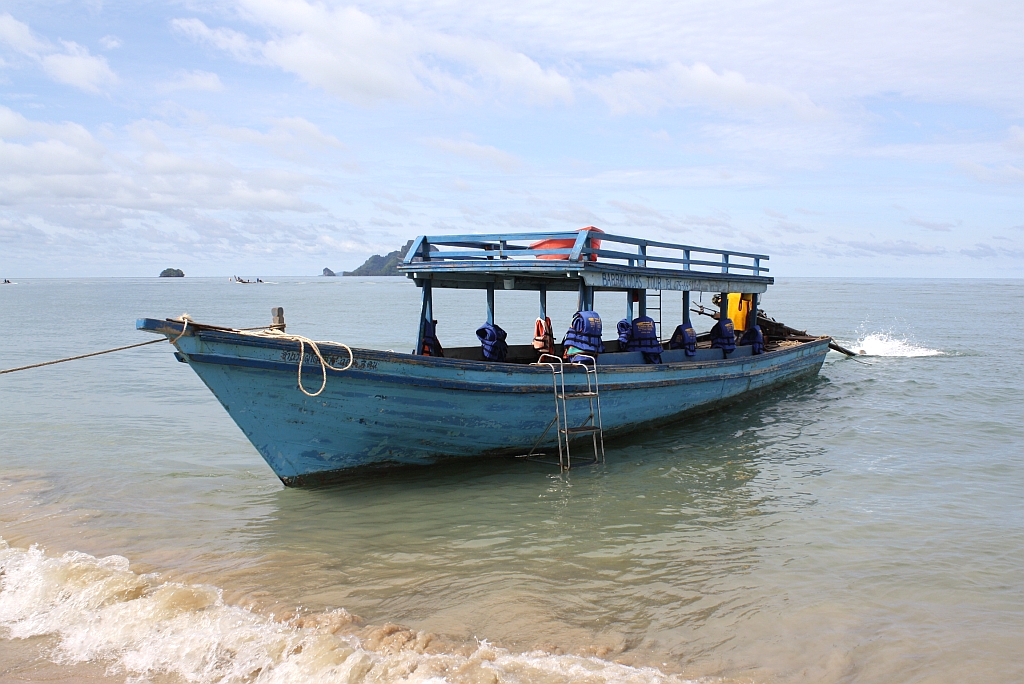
[402,228,769,276]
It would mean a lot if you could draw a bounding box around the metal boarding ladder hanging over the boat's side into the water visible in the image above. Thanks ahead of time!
[524,354,604,472]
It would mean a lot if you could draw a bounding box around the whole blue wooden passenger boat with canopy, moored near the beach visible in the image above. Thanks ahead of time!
[137,228,830,485]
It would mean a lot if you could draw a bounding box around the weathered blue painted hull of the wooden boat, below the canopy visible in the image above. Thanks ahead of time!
[161,331,828,485]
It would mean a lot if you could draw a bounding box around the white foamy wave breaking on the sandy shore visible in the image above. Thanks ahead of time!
[0,539,696,684]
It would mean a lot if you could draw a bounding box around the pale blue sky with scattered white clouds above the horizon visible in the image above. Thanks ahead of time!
[0,0,1024,277]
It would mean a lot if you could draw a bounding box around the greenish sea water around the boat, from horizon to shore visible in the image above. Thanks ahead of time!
[0,277,1024,683]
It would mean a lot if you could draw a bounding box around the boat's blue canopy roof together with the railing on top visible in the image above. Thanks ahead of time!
[398,226,774,293]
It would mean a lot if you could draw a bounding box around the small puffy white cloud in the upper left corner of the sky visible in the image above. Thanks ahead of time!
[0,14,118,92]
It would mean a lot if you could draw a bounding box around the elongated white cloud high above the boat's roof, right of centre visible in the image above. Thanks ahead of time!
[589,62,822,118]
